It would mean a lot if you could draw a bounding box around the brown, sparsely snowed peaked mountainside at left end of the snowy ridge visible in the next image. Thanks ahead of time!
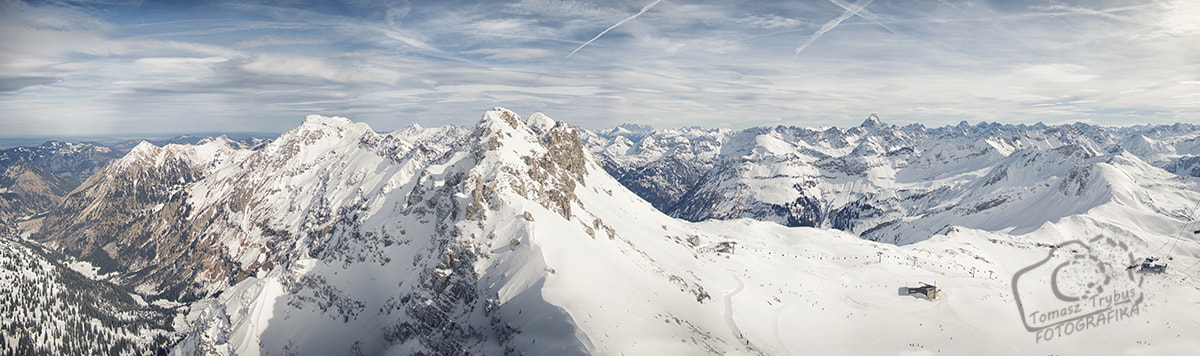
[32,143,232,300]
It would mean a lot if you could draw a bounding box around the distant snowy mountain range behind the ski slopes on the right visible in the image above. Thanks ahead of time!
[584,115,1200,243]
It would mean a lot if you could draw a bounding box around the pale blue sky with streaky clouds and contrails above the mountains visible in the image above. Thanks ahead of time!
[0,0,1200,138]
